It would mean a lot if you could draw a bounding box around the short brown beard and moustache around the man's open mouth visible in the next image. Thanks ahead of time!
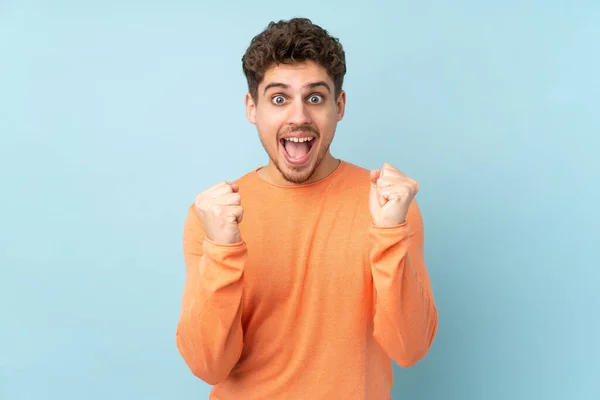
[259,125,331,185]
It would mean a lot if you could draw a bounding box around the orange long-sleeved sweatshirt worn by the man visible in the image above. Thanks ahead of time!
[176,161,437,400]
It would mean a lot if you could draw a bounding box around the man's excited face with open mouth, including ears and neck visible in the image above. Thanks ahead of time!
[246,62,345,184]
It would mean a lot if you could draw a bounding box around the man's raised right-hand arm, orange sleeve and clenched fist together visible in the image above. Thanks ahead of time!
[369,163,438,367]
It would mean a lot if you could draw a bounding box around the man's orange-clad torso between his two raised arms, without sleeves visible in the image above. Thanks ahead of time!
[211,164,394,399]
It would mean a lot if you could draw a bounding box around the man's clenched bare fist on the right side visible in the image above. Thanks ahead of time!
[369,163,419,227]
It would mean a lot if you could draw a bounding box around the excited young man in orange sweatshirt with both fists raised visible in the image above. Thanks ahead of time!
[177,19,438,400]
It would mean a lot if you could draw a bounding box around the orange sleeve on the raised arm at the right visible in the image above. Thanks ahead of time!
[369,201,438,367]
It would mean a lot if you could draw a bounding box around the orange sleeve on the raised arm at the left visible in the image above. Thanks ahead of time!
[176,207,247,385]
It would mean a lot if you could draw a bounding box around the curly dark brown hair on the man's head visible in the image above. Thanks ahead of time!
[242,18,346,101]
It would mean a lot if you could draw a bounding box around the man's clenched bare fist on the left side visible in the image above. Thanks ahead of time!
[194,182,244,244]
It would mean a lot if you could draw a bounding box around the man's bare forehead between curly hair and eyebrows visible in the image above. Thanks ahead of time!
[259,61,333,89]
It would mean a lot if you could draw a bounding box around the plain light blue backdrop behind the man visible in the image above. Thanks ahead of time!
[0,0,600,400]
